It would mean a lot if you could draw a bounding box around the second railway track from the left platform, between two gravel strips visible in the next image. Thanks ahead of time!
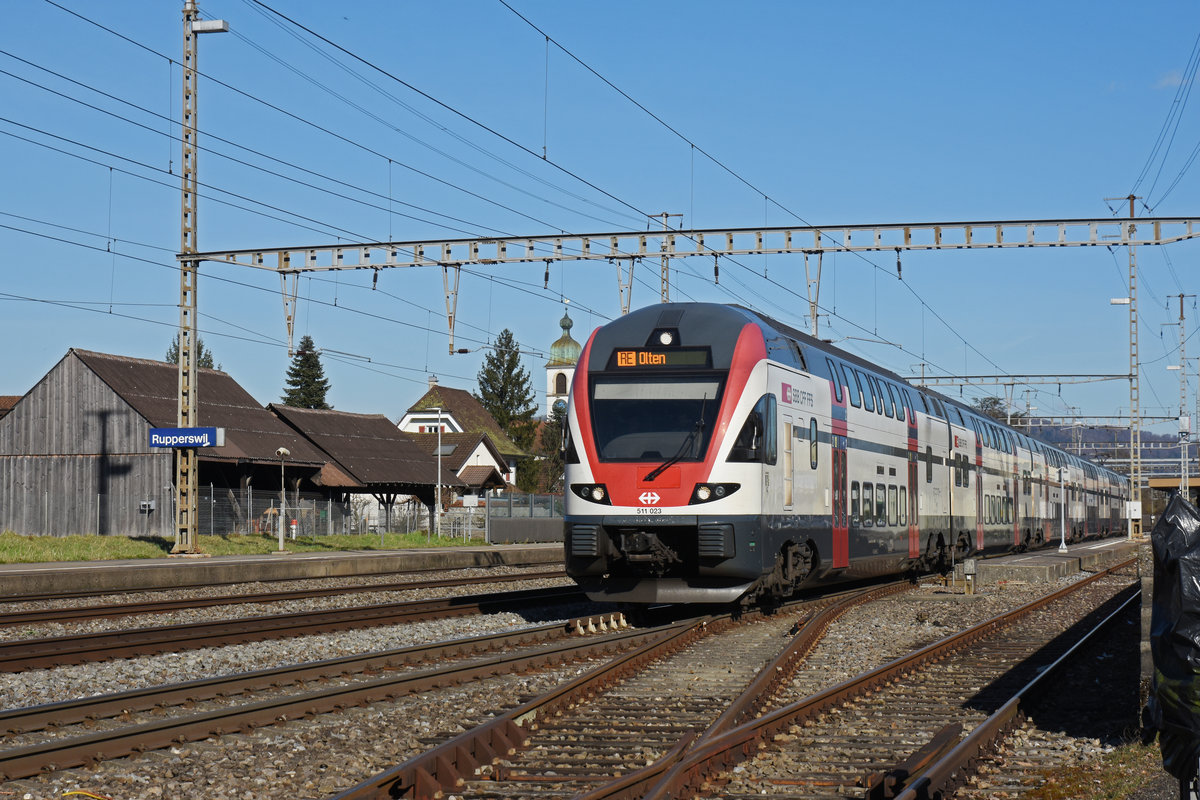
[0,587,588,672]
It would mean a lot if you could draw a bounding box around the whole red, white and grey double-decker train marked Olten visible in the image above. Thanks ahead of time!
[563,302,1129,604]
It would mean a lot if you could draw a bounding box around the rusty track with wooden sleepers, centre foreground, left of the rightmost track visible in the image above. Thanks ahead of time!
[328,583,908,800]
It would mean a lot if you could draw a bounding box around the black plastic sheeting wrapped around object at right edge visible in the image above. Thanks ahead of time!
[1146,494,1200,781]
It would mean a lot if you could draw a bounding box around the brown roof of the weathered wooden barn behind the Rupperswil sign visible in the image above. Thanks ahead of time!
[71,348,328,467]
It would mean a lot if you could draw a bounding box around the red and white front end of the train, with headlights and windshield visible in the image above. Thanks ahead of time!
[564,312,779,603]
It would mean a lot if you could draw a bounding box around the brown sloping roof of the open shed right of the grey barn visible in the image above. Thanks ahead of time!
[268,403,462,488]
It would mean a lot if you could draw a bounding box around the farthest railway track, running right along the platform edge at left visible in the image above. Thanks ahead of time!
[0,570,566,627]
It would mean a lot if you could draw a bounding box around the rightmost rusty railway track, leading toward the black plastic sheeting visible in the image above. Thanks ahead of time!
[633,561,1139,800]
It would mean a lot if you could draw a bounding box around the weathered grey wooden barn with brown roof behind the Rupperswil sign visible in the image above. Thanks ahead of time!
[0,349,329,536]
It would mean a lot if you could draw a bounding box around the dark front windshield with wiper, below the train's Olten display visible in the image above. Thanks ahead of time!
[592,375,722,462]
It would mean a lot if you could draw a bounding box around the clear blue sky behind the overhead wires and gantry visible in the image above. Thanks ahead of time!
[0,0,1200,432]
